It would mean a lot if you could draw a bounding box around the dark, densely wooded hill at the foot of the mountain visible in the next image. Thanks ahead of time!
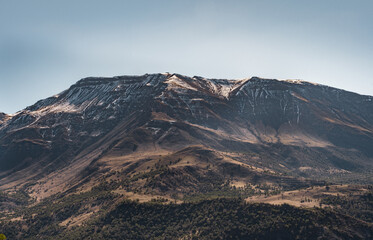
[54,199,373,239]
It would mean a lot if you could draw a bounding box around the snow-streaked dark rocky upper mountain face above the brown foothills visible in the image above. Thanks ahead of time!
[0,74,373,194]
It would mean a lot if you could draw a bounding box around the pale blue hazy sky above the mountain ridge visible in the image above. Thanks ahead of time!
[0,0,373,113]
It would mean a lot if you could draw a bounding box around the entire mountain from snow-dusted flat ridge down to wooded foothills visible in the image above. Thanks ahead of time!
[0,73,373,239]
